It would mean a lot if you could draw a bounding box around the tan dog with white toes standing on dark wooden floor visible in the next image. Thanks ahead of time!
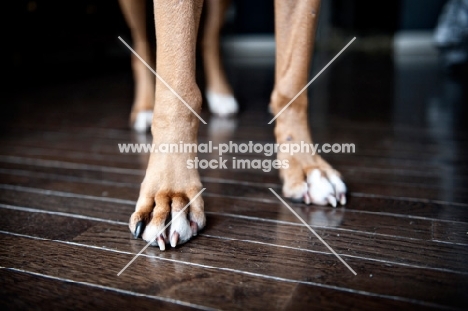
[119,0,346,250]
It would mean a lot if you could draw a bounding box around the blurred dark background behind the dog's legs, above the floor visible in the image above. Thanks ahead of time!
[5,0,468,132]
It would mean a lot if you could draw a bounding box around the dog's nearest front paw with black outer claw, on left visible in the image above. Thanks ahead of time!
[129,154,206,251]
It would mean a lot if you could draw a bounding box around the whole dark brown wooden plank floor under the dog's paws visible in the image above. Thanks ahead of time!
[0,47,468,310]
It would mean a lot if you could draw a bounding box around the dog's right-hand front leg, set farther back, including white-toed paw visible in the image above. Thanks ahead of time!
[271,0,346,206]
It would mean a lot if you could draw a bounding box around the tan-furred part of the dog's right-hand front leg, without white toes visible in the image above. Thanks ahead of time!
[270,0,340,198]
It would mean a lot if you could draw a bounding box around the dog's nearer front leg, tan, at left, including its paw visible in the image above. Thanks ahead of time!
[129,0,205,250]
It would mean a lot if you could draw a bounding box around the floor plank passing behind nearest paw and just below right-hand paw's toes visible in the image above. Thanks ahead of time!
[0,178,468,251]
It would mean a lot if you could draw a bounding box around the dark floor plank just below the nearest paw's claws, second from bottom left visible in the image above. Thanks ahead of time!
[0,234,443,310]
